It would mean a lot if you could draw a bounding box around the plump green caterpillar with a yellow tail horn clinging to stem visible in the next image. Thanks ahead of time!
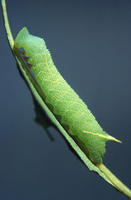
[14,27,120,164]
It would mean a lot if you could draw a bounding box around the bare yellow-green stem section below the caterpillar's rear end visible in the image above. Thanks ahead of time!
[97,163,131,199]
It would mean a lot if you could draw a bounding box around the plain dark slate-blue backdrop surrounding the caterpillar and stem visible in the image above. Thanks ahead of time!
[0,0,131,200]
